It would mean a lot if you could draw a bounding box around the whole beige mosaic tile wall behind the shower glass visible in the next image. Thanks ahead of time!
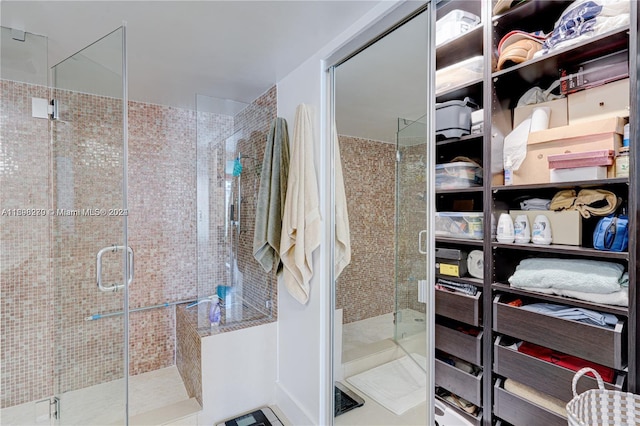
[0,81,275,407]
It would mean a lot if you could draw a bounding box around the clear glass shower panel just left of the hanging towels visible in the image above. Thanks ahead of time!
[196,94,275,331]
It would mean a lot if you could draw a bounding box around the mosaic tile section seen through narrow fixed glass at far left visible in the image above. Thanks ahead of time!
[0,80,55,407]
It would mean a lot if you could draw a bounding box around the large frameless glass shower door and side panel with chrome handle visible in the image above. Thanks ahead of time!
[0,27,134,425]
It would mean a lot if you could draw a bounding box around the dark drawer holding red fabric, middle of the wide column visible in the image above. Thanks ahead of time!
[493,337,626,402]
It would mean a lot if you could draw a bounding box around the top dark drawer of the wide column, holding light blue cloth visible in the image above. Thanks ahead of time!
[493,296,626,370]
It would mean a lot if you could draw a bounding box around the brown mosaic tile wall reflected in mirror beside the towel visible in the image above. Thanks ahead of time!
[336,136,396,324]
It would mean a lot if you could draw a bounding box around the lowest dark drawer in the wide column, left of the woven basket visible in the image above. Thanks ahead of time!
[493,379,567,426]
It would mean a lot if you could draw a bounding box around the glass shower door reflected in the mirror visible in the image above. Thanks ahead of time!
[395,118,428,370]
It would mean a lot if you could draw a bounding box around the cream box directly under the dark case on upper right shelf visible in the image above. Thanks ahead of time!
[568,78,631,124]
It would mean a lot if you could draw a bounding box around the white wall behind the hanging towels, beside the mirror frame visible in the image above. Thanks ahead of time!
[276,1,399,426]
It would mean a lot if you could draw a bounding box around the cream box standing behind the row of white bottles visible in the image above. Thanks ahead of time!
[509,210,582,246]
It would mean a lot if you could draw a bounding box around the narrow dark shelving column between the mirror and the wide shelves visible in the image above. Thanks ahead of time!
[434,0,491,425]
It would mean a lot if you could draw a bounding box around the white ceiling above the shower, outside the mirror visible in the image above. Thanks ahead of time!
[0,0,379,108]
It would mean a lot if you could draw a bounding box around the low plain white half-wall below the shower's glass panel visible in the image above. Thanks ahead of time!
[198,322,277,425]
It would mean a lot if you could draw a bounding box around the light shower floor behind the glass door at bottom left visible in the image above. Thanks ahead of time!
[0,366,200,426]
